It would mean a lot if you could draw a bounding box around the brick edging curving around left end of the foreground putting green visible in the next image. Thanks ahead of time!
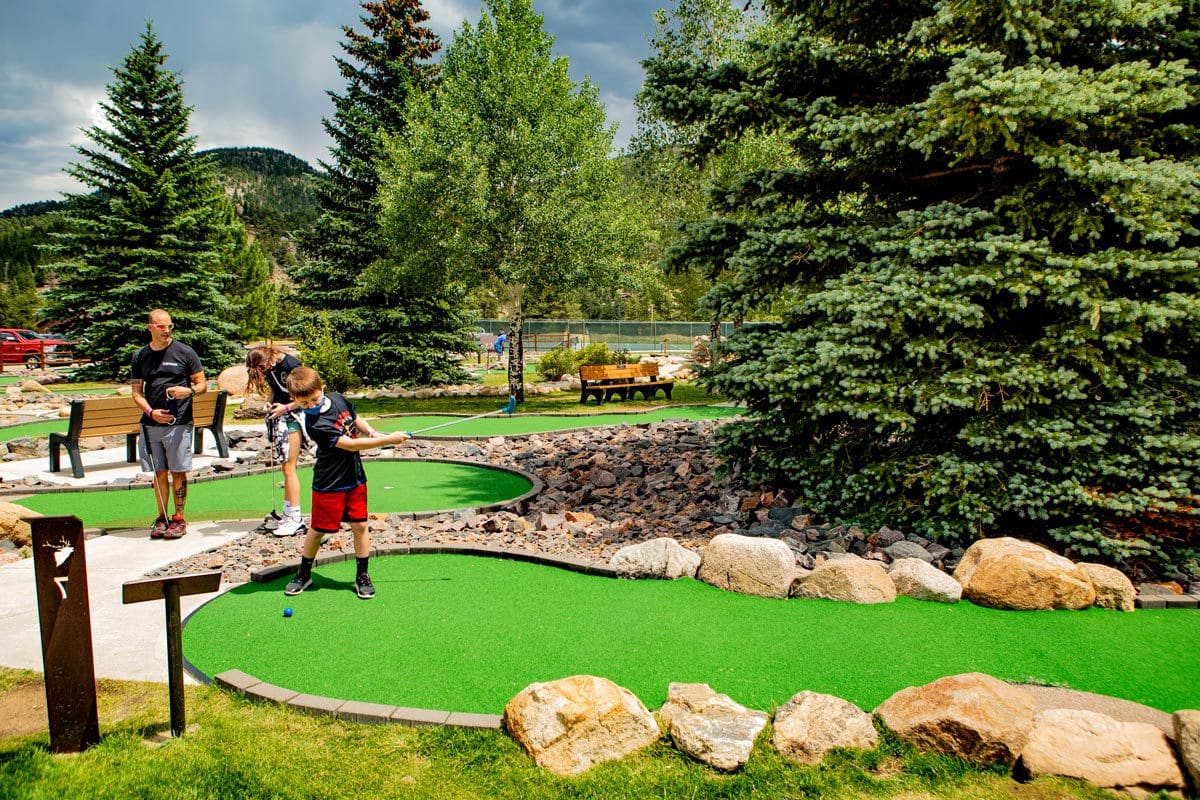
[184,551,617,729]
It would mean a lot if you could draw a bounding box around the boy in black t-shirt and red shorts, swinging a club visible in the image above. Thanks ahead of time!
[283,367,409,600]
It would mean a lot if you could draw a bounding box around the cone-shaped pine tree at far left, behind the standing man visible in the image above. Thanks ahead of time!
[43,24,240,378]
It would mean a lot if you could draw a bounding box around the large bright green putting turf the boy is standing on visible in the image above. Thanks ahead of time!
[184,555,1200,714]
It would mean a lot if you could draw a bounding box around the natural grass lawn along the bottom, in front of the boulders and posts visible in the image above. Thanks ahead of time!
[0,663,1111,800]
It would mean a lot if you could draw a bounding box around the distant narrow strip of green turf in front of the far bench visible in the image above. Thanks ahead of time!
[372,405,743,437]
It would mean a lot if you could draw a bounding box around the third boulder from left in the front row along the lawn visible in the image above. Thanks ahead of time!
[770,692,880,764]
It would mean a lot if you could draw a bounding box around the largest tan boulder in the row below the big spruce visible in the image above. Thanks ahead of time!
[954,536,1096,610]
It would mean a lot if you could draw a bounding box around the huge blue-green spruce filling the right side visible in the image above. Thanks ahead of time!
[648,0,1200,561]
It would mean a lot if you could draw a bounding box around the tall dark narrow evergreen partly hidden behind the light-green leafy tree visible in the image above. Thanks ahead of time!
[290,0,466,384]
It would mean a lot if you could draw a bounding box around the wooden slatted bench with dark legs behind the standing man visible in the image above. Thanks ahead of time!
[50,391,229,477]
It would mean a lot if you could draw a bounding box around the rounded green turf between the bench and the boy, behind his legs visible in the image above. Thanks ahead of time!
[18,461,533,528]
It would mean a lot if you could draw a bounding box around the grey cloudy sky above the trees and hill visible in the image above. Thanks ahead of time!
[0,0,672,210]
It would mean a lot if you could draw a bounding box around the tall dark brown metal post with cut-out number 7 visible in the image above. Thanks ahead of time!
[25,517,100,753]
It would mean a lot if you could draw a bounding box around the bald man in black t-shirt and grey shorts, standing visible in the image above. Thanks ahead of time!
[130,308,209,539]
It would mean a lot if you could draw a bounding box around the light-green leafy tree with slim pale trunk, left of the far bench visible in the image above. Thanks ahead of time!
[371,0,644,397]
